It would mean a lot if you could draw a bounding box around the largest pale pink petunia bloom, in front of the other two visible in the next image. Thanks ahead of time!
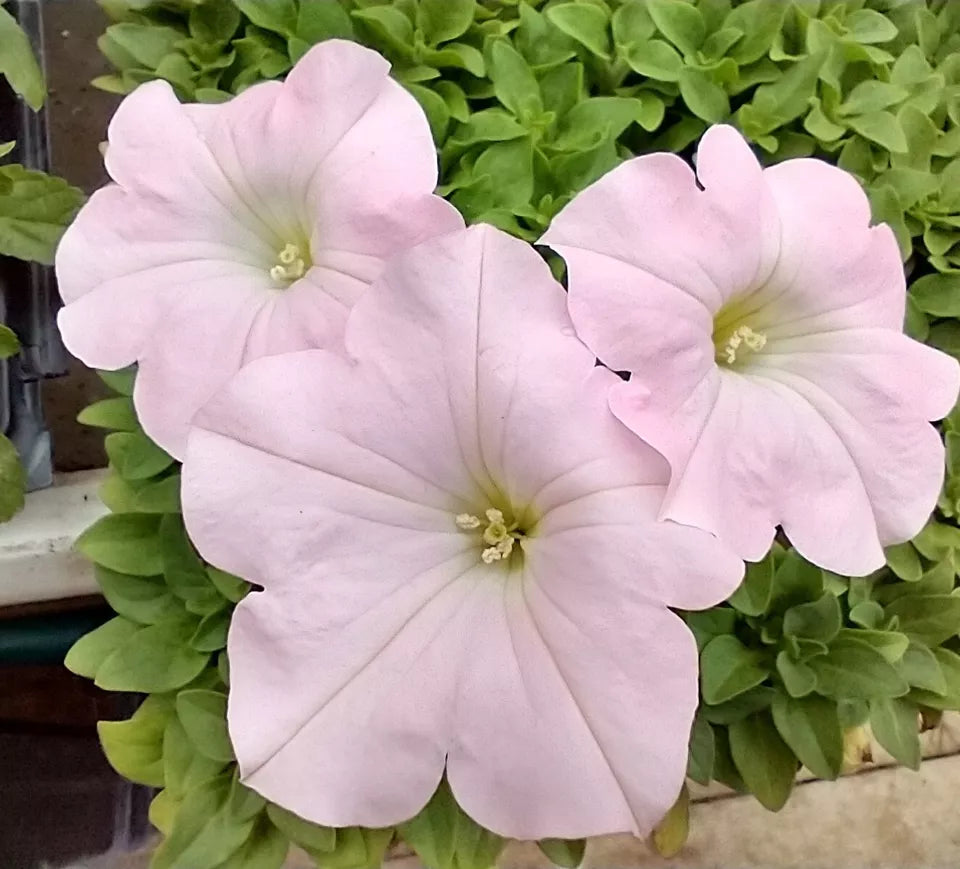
[183,226,743,839]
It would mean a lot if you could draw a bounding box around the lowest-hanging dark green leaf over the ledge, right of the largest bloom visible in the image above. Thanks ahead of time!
[730,712,797,812]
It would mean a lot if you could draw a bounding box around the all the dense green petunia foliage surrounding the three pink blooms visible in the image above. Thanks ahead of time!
[69,0,960,869]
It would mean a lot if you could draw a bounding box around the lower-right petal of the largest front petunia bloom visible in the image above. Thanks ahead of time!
[447,576,697,839]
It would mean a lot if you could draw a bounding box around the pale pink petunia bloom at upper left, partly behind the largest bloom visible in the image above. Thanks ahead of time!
[56,40,463,457]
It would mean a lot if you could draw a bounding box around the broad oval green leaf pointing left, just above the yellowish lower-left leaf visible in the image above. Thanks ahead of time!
[94,618,210,694]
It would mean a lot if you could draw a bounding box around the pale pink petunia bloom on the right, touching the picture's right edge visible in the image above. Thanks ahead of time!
[543,126,960,574]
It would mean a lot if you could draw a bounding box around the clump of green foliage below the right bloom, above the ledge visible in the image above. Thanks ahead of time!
[685,540,960,809]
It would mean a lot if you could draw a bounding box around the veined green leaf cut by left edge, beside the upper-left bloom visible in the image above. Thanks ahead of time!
[0,164,83,265]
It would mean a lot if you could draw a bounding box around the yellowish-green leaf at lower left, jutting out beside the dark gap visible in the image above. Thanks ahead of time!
[97,697,173,788]
